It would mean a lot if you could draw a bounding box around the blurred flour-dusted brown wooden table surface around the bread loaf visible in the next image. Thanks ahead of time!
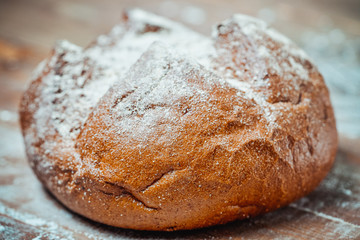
[0,0,360,239]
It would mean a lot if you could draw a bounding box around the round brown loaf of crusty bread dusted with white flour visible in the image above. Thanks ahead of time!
[20,10,337,231]
